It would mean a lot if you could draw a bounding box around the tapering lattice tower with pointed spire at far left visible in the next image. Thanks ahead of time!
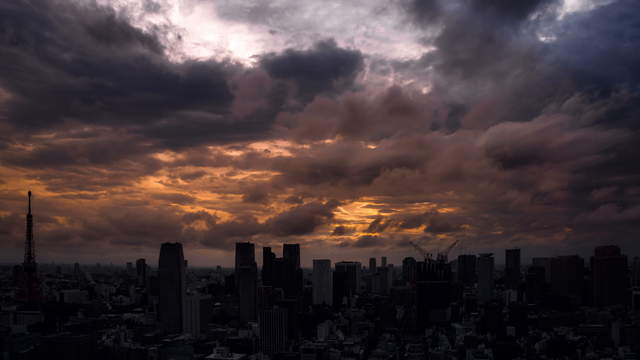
[18,191,40,305]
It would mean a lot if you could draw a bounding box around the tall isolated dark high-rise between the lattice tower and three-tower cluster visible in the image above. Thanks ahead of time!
[158,243,186,333]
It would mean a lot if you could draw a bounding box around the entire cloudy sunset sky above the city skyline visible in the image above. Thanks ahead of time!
[0,0,640,266]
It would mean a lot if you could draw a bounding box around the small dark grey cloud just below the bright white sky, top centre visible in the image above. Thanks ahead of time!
[260,40,364,101]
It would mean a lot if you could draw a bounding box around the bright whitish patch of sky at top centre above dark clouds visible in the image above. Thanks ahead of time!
[90,0,426,65]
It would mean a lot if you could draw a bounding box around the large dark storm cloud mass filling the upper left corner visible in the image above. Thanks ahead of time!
[0,0,232,128]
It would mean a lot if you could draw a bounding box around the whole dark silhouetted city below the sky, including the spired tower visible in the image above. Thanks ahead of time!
[0,193,640,360]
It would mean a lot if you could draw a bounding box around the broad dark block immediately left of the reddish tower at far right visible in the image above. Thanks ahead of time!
[550,255,584,305]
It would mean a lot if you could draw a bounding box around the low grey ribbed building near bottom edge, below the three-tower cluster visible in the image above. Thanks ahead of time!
[259,307,288,355]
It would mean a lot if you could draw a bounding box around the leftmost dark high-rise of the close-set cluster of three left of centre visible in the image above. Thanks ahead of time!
[235,242,258,322]
